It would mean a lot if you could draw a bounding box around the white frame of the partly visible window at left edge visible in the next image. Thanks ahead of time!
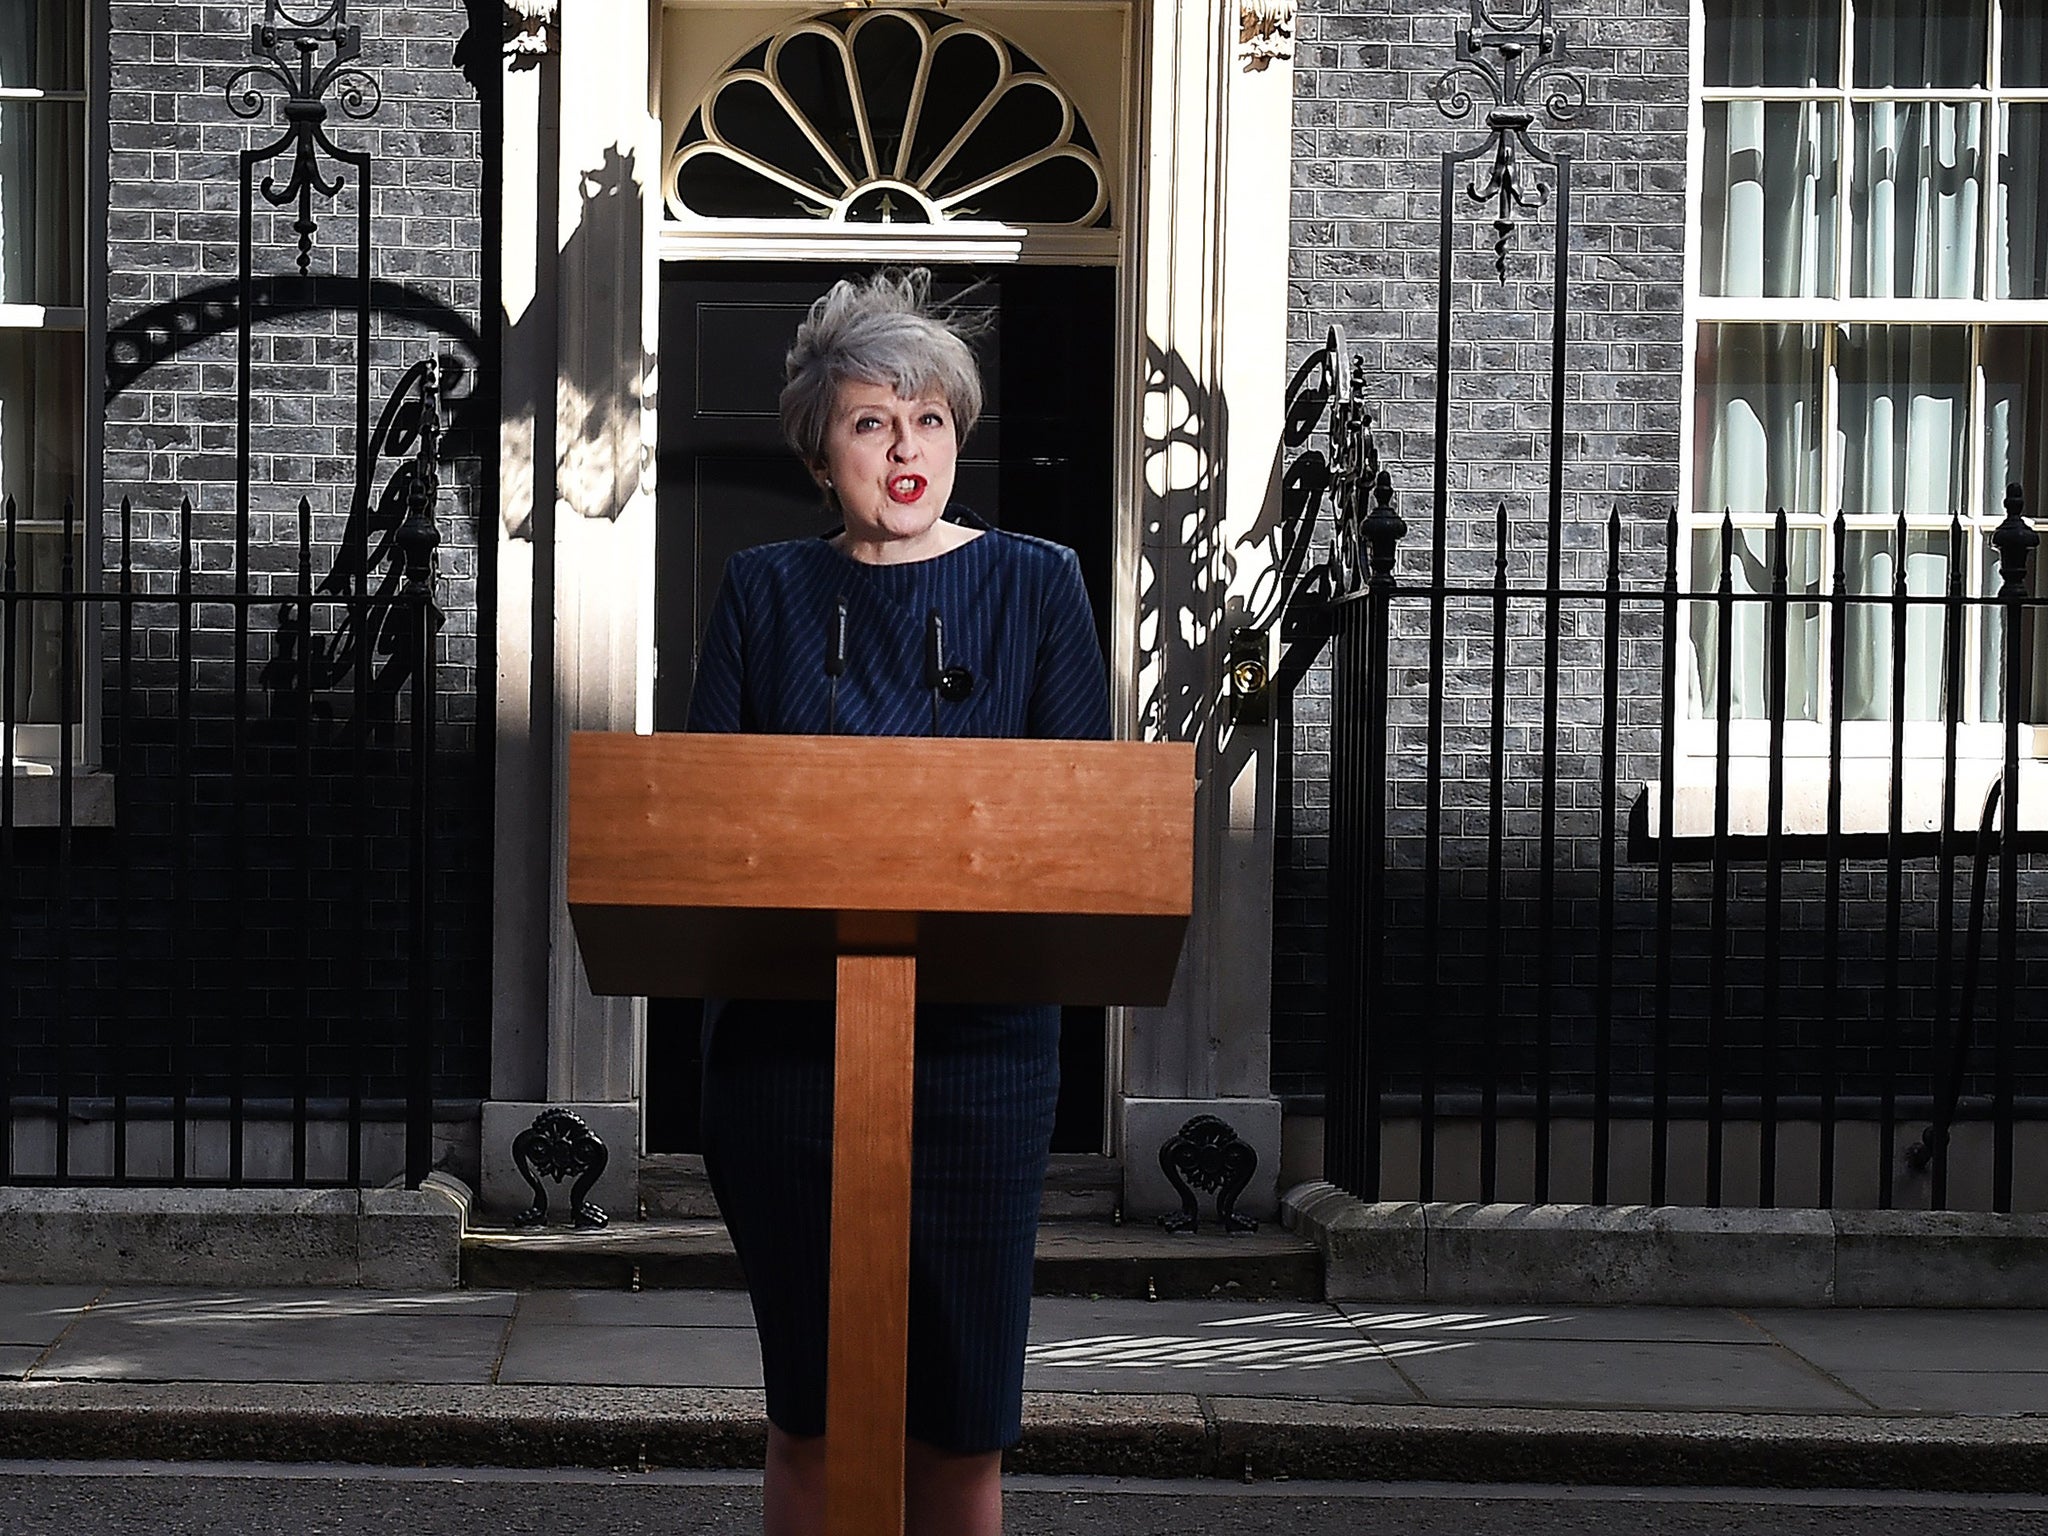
[0,0,109,782]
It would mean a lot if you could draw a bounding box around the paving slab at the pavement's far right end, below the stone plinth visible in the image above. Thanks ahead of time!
[1749,1309,2048,1376]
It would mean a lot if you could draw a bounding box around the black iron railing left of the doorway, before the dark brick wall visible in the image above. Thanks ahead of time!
[0,362,442,1186]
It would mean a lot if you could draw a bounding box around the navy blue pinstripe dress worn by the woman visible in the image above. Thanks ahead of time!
[690,508,1110,1452]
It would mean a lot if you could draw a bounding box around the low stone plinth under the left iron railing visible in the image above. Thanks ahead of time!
[0,1174,469,1290]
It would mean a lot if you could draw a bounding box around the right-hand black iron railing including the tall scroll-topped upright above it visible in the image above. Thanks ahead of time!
[1280,0,2048,1210]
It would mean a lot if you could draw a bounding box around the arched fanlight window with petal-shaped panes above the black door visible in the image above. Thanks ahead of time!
[666,8,1110,227]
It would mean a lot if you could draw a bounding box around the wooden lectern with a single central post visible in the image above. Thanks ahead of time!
[569,733,1194,1536]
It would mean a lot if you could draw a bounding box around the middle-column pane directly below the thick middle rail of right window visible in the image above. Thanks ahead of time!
[1839,326,1970,522]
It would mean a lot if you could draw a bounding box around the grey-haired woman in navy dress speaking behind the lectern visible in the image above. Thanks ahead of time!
[690,270,1110,1536]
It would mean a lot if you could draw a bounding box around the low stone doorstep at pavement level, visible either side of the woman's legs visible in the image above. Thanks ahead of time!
[463,1219,1323,1300]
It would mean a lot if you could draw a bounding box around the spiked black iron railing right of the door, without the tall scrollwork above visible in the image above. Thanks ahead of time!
[1296,391,2048,1210]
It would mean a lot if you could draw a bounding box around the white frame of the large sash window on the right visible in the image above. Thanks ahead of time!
[1671,0,2048,774]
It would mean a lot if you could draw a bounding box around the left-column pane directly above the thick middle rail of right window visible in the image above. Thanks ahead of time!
[1700,100,1839,299]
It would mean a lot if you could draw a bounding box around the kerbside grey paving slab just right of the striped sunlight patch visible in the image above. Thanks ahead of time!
[1386,1337,1868,1413]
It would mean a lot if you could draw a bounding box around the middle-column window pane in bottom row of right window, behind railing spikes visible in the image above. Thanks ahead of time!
[1841,528,1962,721]
